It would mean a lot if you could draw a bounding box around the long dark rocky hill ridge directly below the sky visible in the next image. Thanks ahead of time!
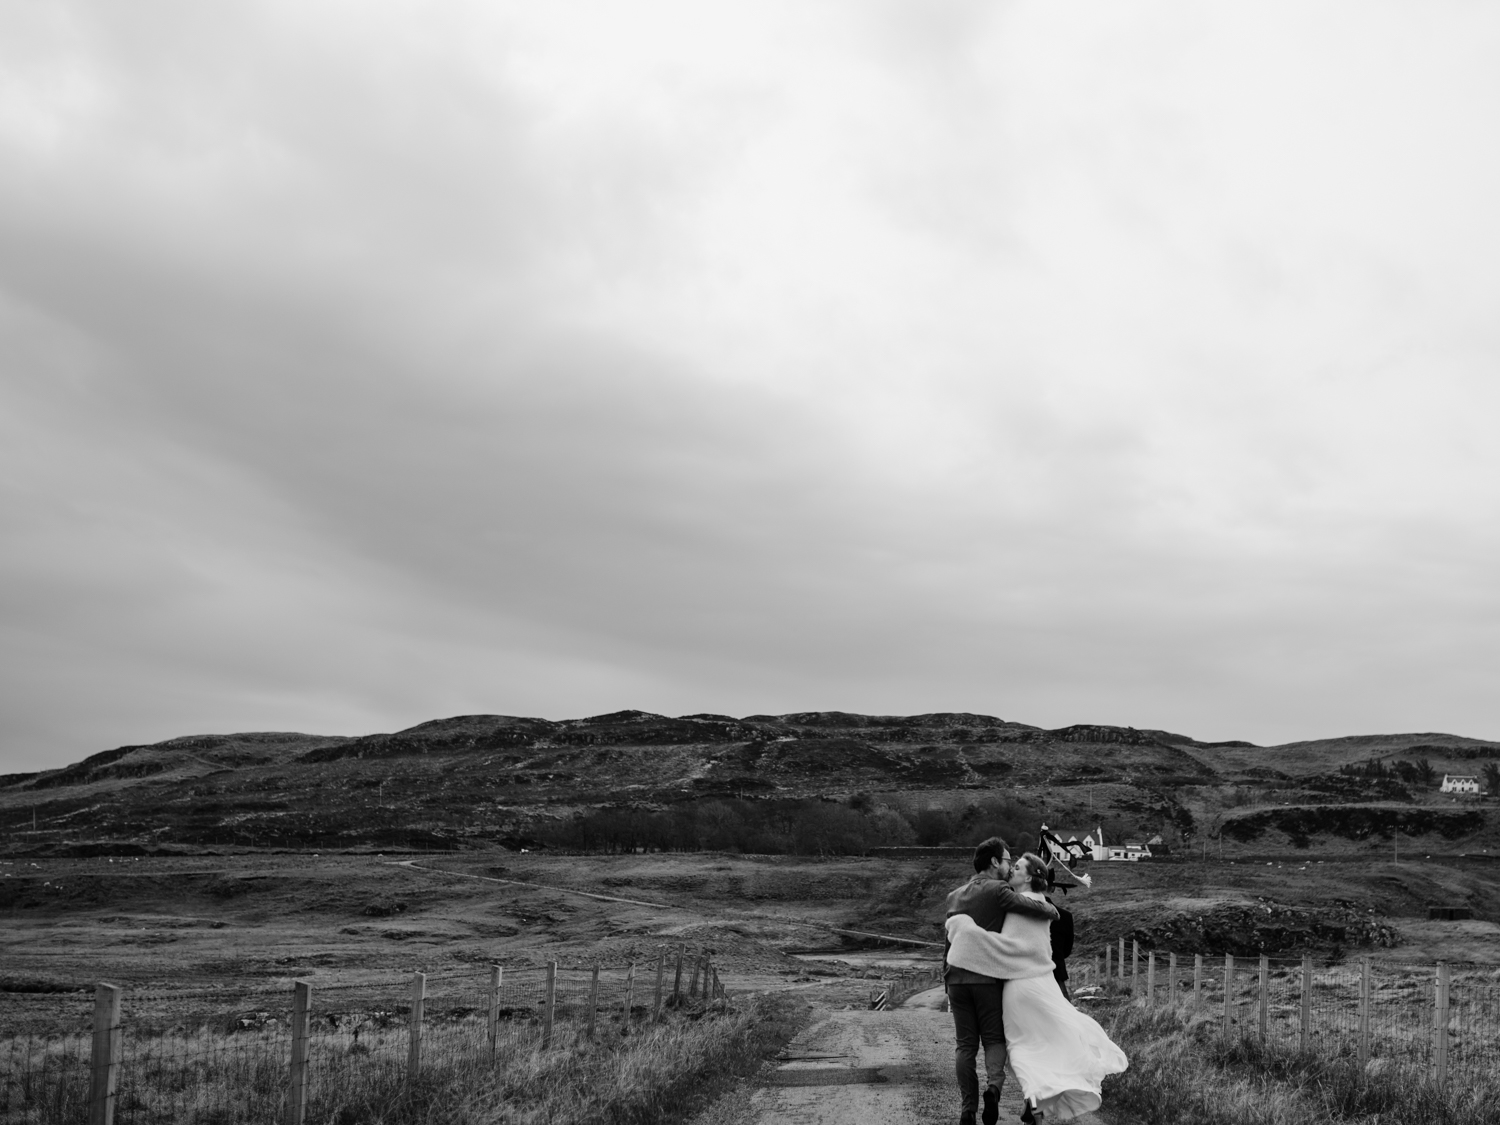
[0,711,1500,855]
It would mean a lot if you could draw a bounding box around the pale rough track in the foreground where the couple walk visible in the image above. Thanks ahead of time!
[750,990,1103,1125]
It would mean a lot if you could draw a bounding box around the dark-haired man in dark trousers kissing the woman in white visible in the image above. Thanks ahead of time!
[944,836,1058,1125]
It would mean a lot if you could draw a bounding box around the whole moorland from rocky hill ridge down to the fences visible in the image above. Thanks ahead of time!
[0,711,1500,989]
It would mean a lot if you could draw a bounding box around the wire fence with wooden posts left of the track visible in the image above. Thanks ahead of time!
[0,948,728,1125]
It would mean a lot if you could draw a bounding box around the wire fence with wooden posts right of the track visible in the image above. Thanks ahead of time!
[1085,942,1500,1088]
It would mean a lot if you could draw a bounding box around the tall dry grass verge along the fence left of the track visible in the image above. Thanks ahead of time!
[0,998,807,1125]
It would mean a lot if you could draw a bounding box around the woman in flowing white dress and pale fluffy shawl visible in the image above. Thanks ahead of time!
[947,852,1128,1125]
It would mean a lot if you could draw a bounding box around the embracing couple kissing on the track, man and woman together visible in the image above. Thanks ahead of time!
[944,836,1127,1125]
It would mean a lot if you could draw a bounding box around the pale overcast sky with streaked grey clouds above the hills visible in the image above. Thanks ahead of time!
[0,0,1500,771]
